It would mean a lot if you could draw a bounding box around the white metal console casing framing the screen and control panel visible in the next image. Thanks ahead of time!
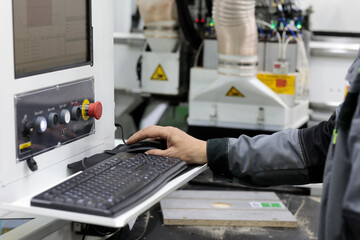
[0,0,115,206]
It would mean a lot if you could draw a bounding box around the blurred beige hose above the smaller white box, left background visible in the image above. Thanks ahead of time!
[137,0,179,52]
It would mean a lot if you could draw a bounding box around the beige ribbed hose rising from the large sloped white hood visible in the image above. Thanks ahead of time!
[213,0,258,76]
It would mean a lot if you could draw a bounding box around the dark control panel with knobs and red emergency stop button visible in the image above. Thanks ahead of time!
[14,77,102,161]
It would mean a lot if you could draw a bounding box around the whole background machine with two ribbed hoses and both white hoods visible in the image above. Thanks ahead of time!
[132,0,309,133]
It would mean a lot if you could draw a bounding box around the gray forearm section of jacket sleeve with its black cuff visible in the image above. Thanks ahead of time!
[207,130,309,186]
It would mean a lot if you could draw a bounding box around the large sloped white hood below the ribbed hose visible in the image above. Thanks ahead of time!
[188,68,309,131]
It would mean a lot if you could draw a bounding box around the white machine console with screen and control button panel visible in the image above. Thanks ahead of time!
[0,0,115,219]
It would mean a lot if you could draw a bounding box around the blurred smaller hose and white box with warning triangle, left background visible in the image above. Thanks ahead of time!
[137,0,186,96]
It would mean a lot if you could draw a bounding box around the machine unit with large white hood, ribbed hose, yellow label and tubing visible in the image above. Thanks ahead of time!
[188,0,309,131]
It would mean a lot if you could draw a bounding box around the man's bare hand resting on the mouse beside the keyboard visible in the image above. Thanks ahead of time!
[127,126,207,164]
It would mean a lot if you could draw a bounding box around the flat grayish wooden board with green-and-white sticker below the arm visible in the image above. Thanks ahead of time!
[160,190,297,227]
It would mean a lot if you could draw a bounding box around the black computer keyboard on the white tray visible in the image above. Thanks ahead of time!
[31,153,187,216]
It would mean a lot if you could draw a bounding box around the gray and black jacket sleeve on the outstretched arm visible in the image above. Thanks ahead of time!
[207,114,335,186]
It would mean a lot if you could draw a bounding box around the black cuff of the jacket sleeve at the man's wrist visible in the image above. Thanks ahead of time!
[206,138,232,177]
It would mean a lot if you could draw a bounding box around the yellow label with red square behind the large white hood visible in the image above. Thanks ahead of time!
[257,73,296,95]
